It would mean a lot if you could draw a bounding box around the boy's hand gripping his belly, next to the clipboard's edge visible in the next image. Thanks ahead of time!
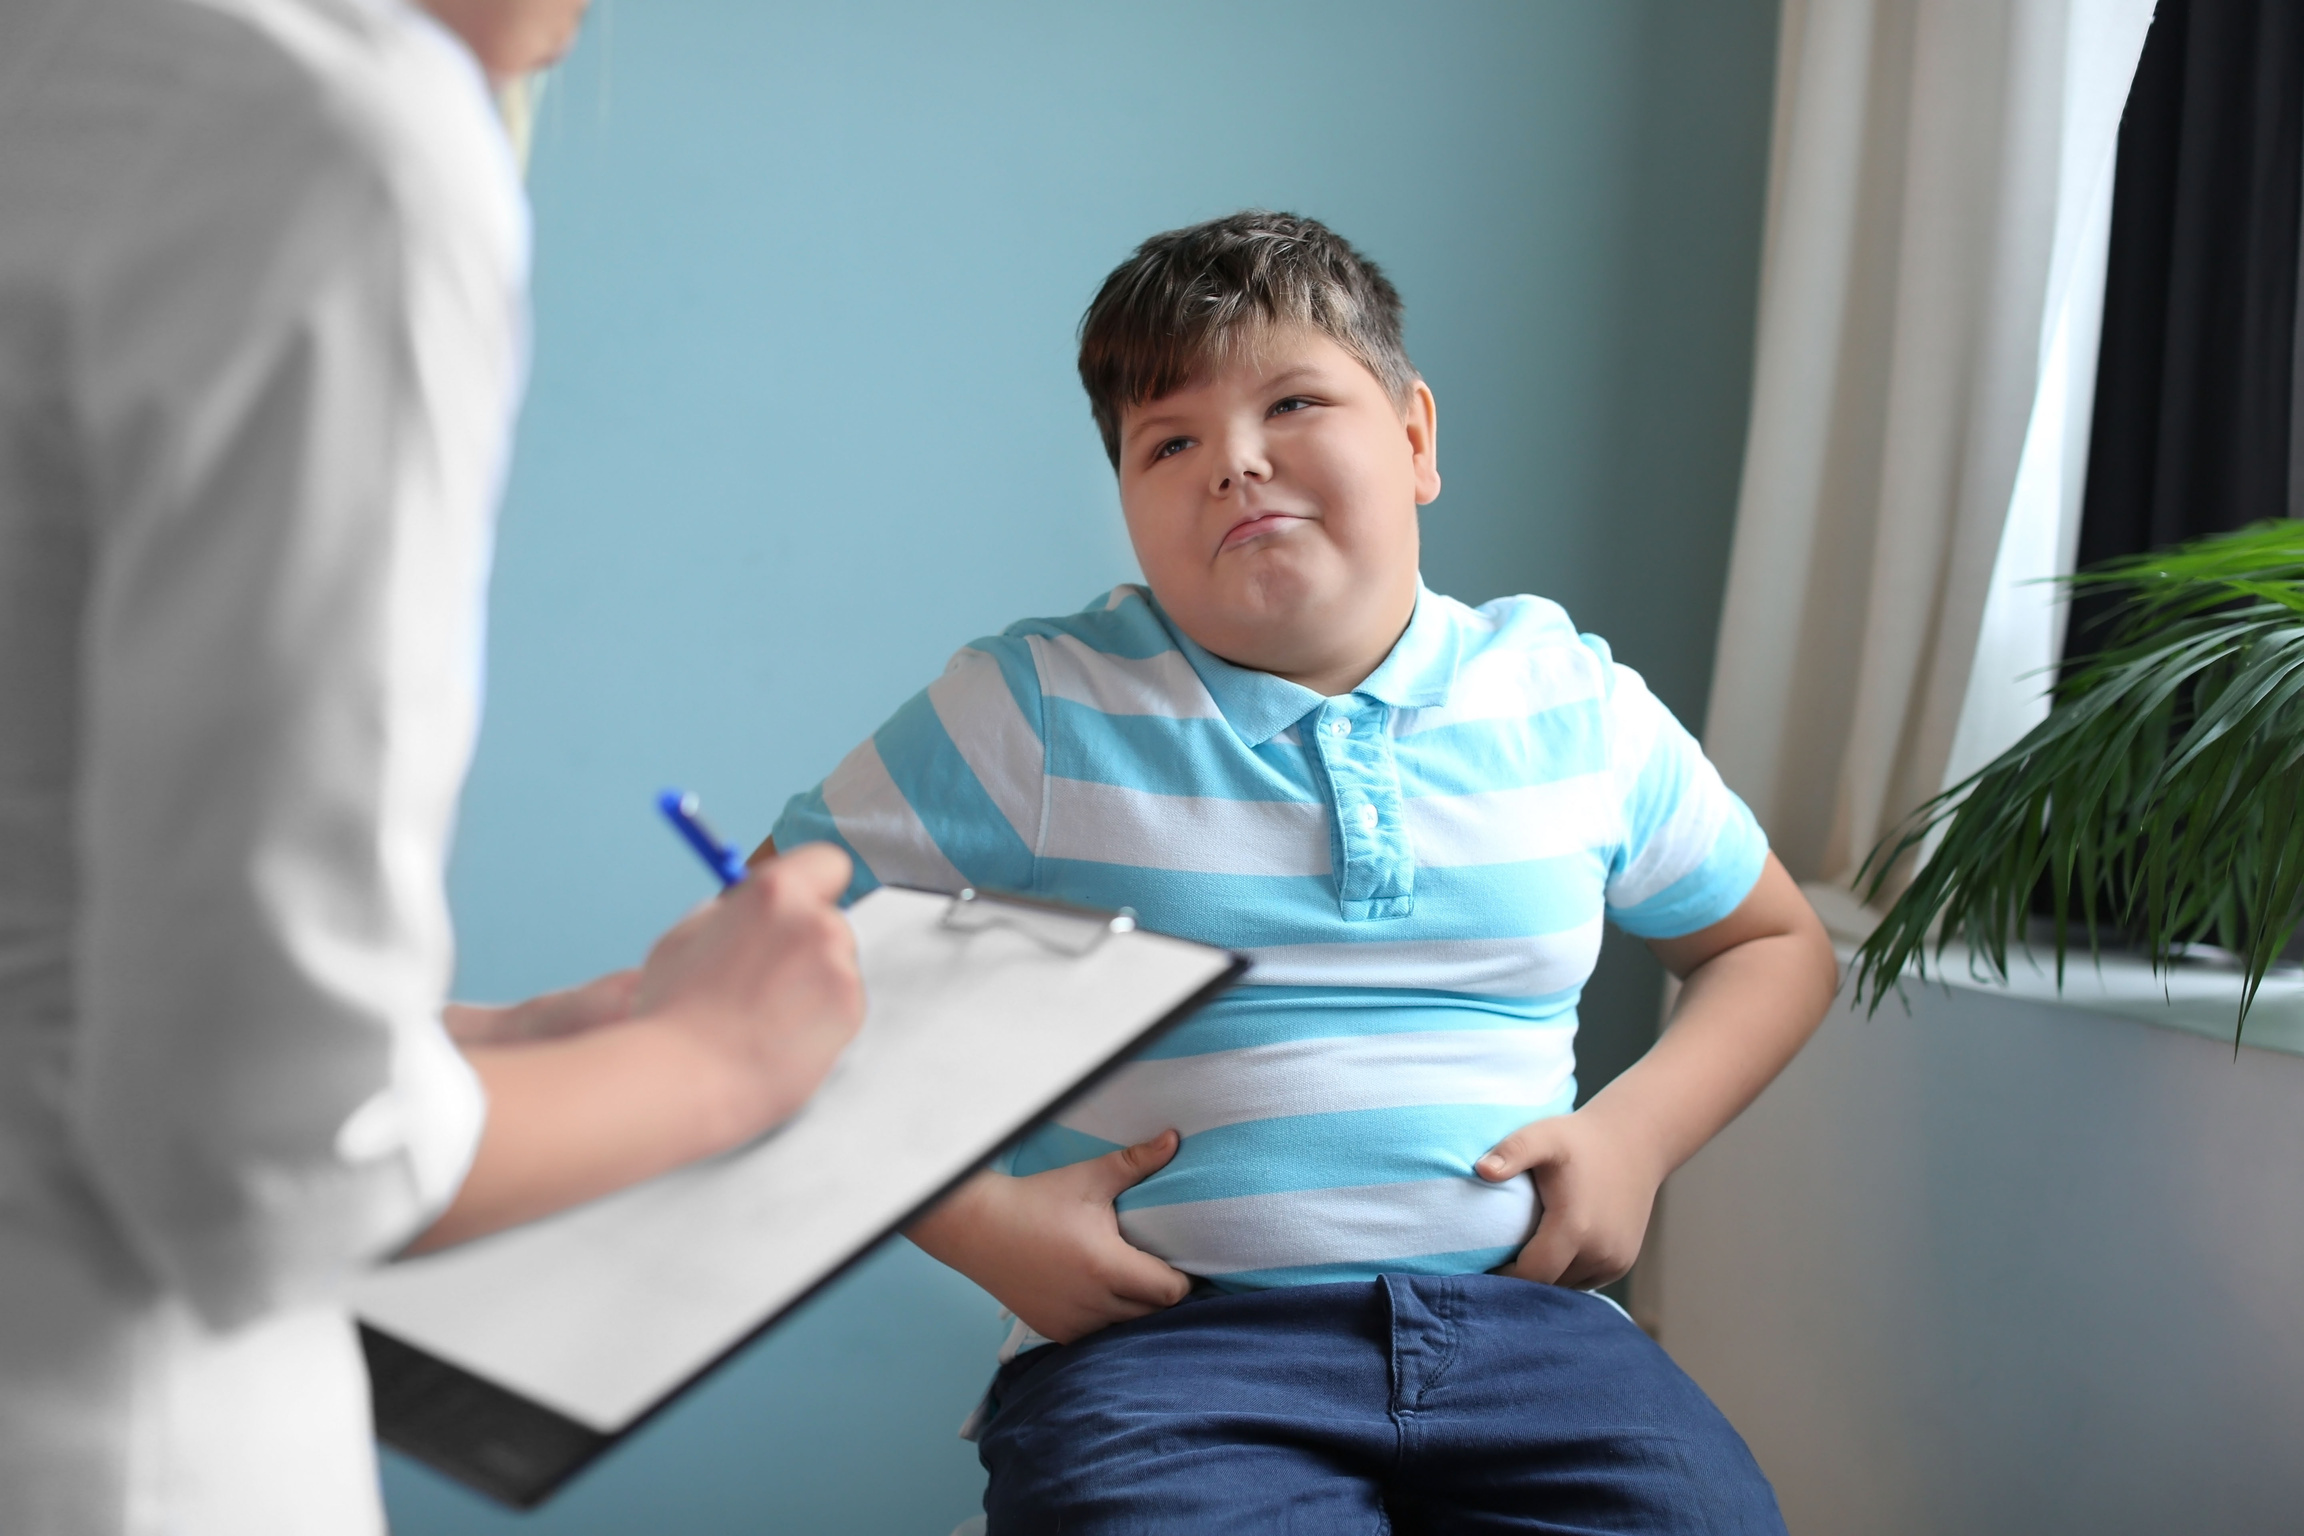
[905,1131,1191,1345]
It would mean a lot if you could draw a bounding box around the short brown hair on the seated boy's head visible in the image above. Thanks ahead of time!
[1081,210,1417,467]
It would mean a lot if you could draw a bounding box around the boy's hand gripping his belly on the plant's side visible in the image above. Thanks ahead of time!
[1472,1105,1666,1290]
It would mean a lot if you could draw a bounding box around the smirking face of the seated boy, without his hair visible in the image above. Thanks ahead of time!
[1120,327,1440,695]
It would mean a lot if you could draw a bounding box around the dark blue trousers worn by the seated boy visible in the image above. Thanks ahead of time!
[977,1273,1783,1536]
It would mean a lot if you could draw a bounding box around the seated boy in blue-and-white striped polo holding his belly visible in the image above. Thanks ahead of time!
[772,212,1836,1536]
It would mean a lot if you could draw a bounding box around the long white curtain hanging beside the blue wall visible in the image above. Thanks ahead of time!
[1705,0,2152,919]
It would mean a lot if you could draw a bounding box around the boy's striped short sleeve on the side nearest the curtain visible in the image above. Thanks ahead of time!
[1585,636,1767,940]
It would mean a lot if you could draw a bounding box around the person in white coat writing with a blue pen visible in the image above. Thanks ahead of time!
[0,0,862,1536]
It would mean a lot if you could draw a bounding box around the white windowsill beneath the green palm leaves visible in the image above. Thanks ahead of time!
[1804,887,2304,1057]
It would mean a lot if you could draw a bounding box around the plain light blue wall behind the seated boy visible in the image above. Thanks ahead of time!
[387,0,1774,1536]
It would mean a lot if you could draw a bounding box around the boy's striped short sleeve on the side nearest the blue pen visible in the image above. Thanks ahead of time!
[774,636,1046,900]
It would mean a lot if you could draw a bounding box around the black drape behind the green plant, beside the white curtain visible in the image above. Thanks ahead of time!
[2067,0,2304,656]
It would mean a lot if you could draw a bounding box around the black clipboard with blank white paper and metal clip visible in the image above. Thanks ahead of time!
[353,887,1249,1508]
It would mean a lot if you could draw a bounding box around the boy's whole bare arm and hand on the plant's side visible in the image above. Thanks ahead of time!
[1475,854,1839,1287]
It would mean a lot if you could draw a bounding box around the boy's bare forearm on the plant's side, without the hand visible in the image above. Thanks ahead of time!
[1585,854,1839,1179]
